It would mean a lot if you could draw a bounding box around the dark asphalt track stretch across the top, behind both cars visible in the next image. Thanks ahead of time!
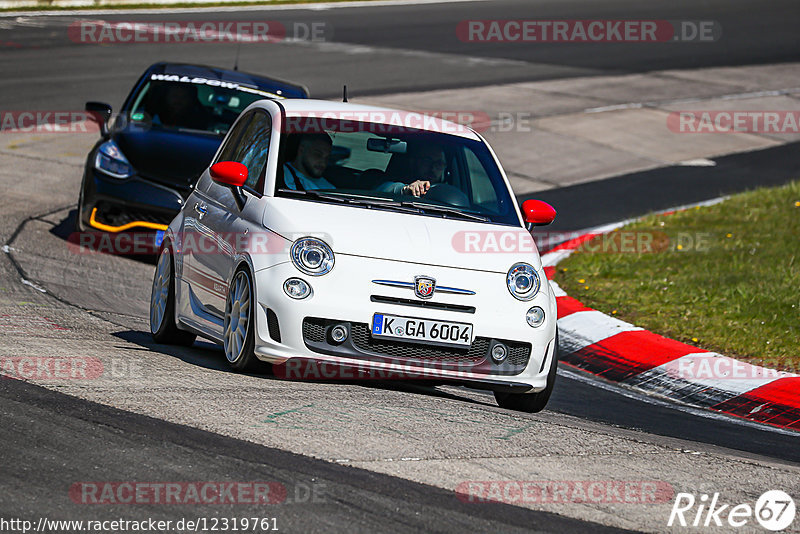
[0,0,800,109]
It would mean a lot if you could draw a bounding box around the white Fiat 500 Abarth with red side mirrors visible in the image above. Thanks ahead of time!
[150,99,558,412]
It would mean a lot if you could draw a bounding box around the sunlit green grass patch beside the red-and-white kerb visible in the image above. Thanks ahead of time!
[555,182,800,372]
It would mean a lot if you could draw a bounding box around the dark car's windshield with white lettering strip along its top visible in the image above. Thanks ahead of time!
[129,74,275,135]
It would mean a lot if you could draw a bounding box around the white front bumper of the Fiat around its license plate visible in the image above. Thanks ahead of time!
[250,254,556,392]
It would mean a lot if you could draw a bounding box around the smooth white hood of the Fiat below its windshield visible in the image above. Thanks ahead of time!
[264,197,541,273]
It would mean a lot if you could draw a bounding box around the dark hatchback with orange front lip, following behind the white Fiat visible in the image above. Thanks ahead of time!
[76,63,308,233]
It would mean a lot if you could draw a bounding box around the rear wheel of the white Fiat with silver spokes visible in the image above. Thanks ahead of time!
[150,243,197,346]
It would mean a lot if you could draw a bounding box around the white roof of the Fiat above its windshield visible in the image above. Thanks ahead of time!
[268,98,480,141]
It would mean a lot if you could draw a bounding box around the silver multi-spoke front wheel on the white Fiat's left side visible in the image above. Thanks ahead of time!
[222,268,260,371]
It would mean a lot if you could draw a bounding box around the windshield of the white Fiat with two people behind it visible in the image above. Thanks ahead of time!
[275,120,520,226]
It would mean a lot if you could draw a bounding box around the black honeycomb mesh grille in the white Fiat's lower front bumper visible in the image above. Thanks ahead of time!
[303,318,531,367]
